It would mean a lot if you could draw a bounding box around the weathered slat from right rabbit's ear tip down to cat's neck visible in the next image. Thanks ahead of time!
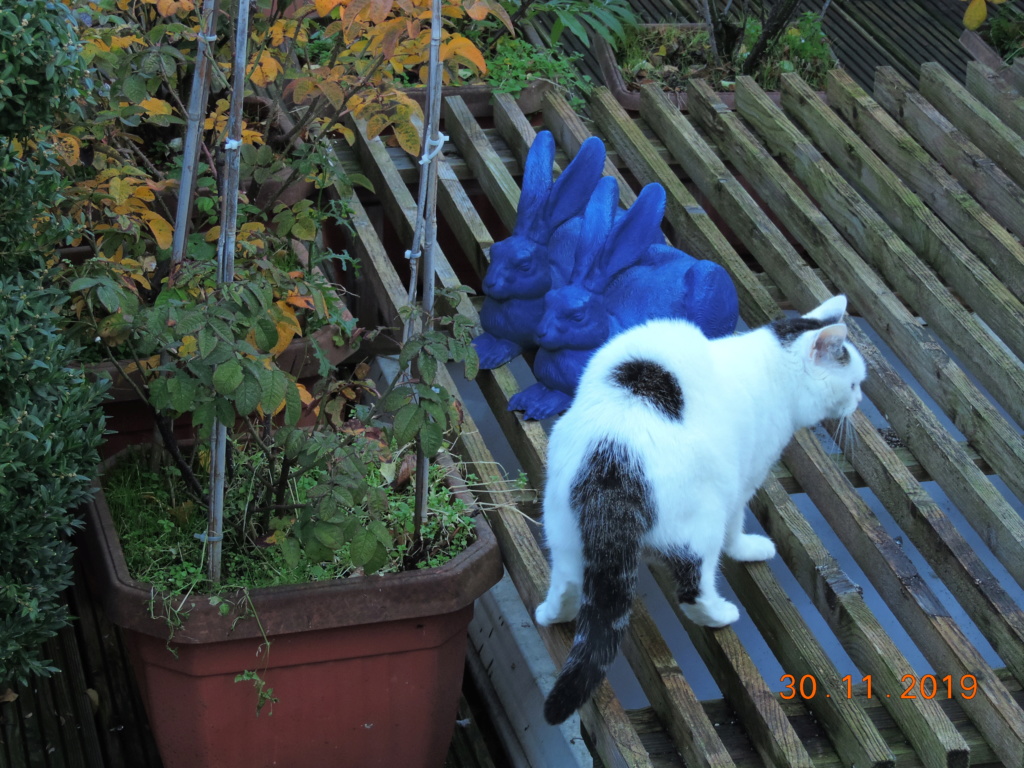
[590,88,771,324]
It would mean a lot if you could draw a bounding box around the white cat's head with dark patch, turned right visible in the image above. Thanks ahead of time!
[770,296,867,426]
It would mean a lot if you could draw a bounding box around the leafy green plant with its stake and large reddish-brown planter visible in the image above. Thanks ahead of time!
[72,6,501,768]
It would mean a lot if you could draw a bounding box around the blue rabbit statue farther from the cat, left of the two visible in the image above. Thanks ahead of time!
[473,131,605,369]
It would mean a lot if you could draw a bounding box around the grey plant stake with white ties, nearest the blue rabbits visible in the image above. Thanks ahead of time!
[406,0,445,521]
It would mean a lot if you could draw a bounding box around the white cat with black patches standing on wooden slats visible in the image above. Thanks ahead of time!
[537,296,866,724]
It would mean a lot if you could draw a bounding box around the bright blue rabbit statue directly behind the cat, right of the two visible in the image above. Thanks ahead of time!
[509,179,739,419]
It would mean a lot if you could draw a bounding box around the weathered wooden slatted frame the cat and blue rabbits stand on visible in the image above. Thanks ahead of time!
[333,60,1024,766]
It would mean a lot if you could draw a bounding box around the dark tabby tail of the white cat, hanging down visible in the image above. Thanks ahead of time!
[544,442,654,725]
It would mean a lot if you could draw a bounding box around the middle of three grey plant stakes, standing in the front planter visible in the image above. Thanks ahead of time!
[206,0,250,583]
